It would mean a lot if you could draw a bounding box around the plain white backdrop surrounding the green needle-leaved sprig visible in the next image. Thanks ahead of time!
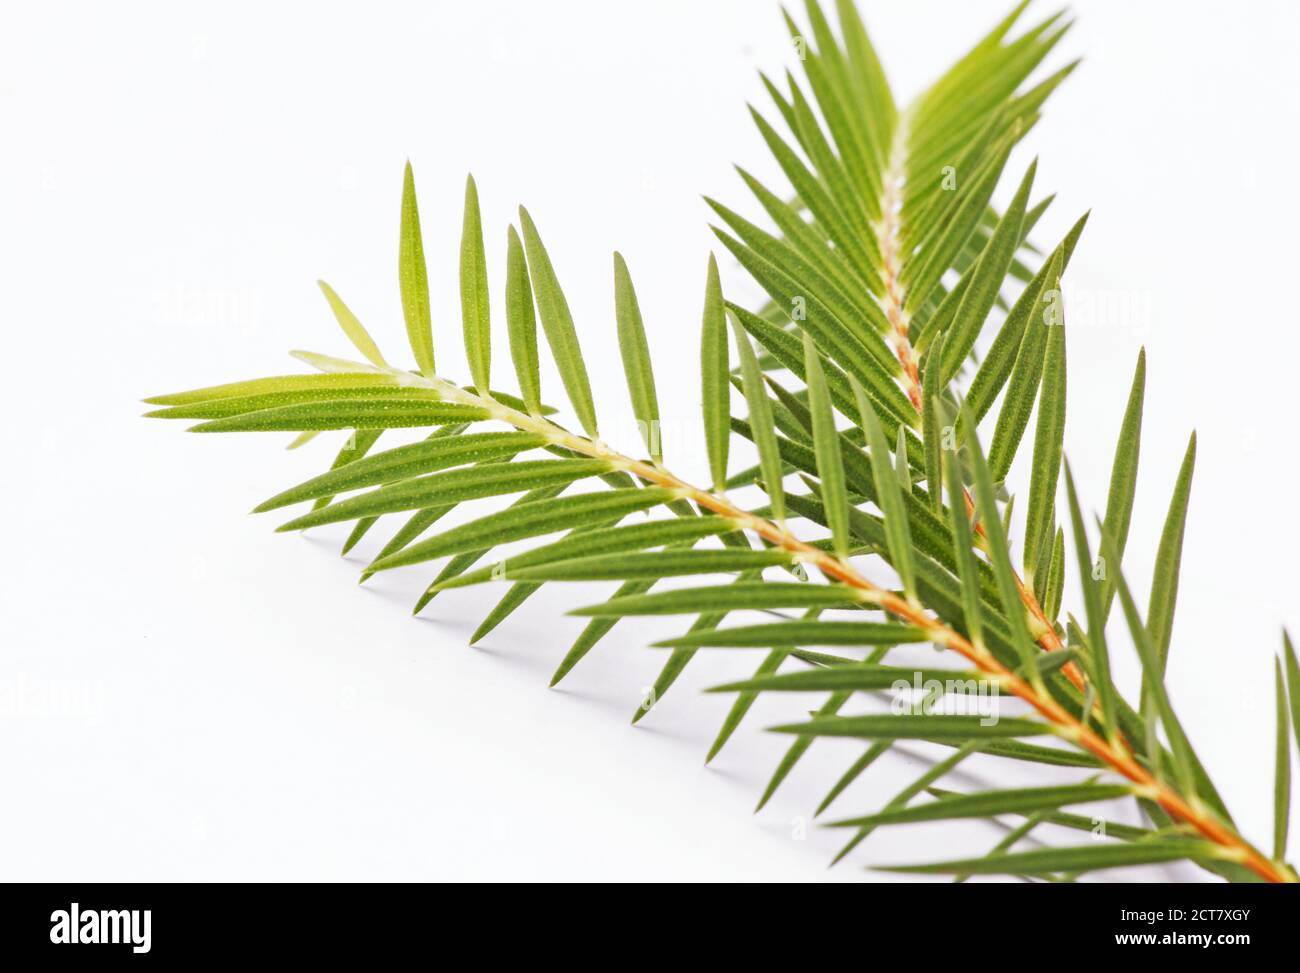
[0,0,1300,881]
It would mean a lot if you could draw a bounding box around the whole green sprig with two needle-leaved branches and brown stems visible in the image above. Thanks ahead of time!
[147,0,1300,881]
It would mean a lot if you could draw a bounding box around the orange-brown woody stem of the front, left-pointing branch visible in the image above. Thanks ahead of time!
[366,364,1297,883]
